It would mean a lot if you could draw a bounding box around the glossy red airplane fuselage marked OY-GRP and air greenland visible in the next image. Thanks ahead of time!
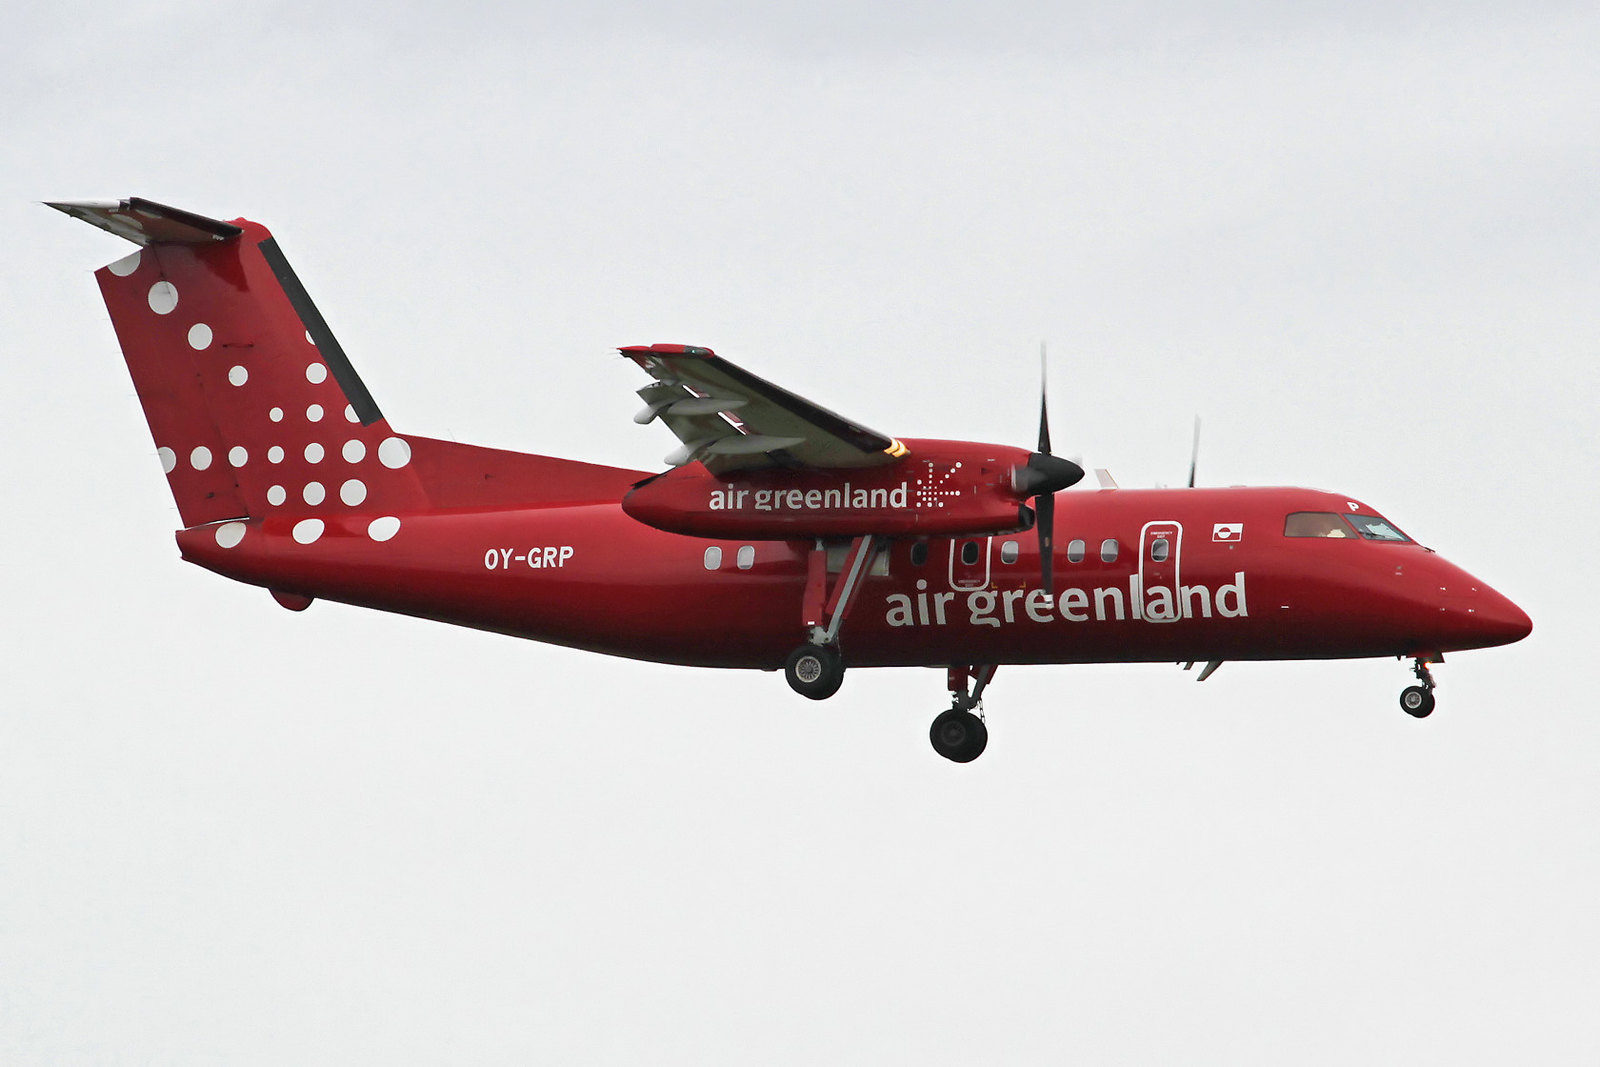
[179,473,1530,669]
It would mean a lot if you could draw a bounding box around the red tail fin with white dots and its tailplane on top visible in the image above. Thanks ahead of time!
[50,198,441,526]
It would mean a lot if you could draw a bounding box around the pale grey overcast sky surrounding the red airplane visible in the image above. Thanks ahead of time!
[0,2,1600,1065]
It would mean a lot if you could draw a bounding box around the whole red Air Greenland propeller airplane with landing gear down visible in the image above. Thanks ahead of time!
[48,197,1533,763]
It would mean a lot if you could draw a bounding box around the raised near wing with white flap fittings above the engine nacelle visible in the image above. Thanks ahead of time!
[621,344,906,474]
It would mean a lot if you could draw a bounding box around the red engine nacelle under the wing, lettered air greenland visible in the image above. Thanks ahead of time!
[622,440,1032,541]
